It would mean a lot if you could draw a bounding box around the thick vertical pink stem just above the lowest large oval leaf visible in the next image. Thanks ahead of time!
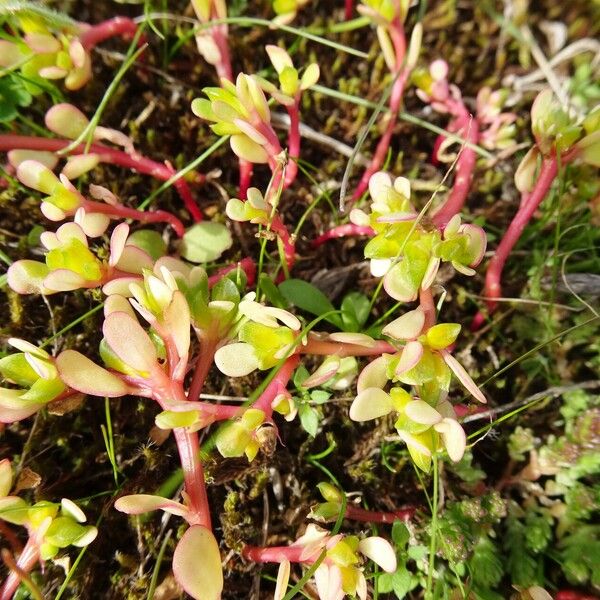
[173,428,211,529]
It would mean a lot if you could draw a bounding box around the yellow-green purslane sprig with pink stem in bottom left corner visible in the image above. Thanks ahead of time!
[0,459,98,600]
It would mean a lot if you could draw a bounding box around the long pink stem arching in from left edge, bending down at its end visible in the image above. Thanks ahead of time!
[0,134,204,221]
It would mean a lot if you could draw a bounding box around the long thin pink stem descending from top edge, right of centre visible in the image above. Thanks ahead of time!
[352,19,410,201]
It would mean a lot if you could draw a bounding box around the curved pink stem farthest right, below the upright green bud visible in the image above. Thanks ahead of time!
[484,157,558,313]
